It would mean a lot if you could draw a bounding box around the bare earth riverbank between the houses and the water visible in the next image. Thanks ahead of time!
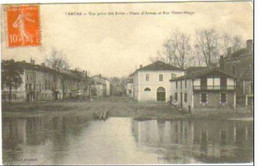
[2,97,253,120]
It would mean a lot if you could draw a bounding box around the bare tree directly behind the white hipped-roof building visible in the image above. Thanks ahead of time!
[163,30,191,68]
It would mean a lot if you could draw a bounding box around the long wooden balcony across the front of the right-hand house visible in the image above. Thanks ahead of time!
[193,85,236,91]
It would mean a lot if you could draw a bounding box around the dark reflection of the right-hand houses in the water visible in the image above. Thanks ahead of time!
[132,120,253,163]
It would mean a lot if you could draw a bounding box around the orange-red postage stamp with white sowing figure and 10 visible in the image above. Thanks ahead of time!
[6,5,41,47]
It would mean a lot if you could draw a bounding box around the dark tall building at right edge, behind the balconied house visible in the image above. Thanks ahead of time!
[219,40,254,106]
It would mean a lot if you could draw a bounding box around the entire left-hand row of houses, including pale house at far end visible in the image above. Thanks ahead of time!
[2,59,110,102]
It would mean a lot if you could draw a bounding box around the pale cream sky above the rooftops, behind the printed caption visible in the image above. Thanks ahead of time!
[1,2,253,77]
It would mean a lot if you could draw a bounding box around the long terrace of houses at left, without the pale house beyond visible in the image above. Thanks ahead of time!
[2,60,86,102]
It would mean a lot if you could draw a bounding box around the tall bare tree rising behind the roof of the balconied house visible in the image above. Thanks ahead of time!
[195,29,219,67]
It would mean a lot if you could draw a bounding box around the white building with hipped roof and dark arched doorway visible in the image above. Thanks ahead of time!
[132,61,184,101]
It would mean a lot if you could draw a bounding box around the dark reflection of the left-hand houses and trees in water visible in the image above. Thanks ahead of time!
[3,116,88,164]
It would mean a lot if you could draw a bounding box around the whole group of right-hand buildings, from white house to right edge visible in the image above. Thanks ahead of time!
[126,40,253,111]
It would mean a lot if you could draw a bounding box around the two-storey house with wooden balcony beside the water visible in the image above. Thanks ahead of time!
[170,68,236,111]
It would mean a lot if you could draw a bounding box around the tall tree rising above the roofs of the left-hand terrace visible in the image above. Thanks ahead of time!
[45,49,69,99]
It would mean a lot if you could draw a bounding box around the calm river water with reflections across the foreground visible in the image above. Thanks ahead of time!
[3,116,253,165]
